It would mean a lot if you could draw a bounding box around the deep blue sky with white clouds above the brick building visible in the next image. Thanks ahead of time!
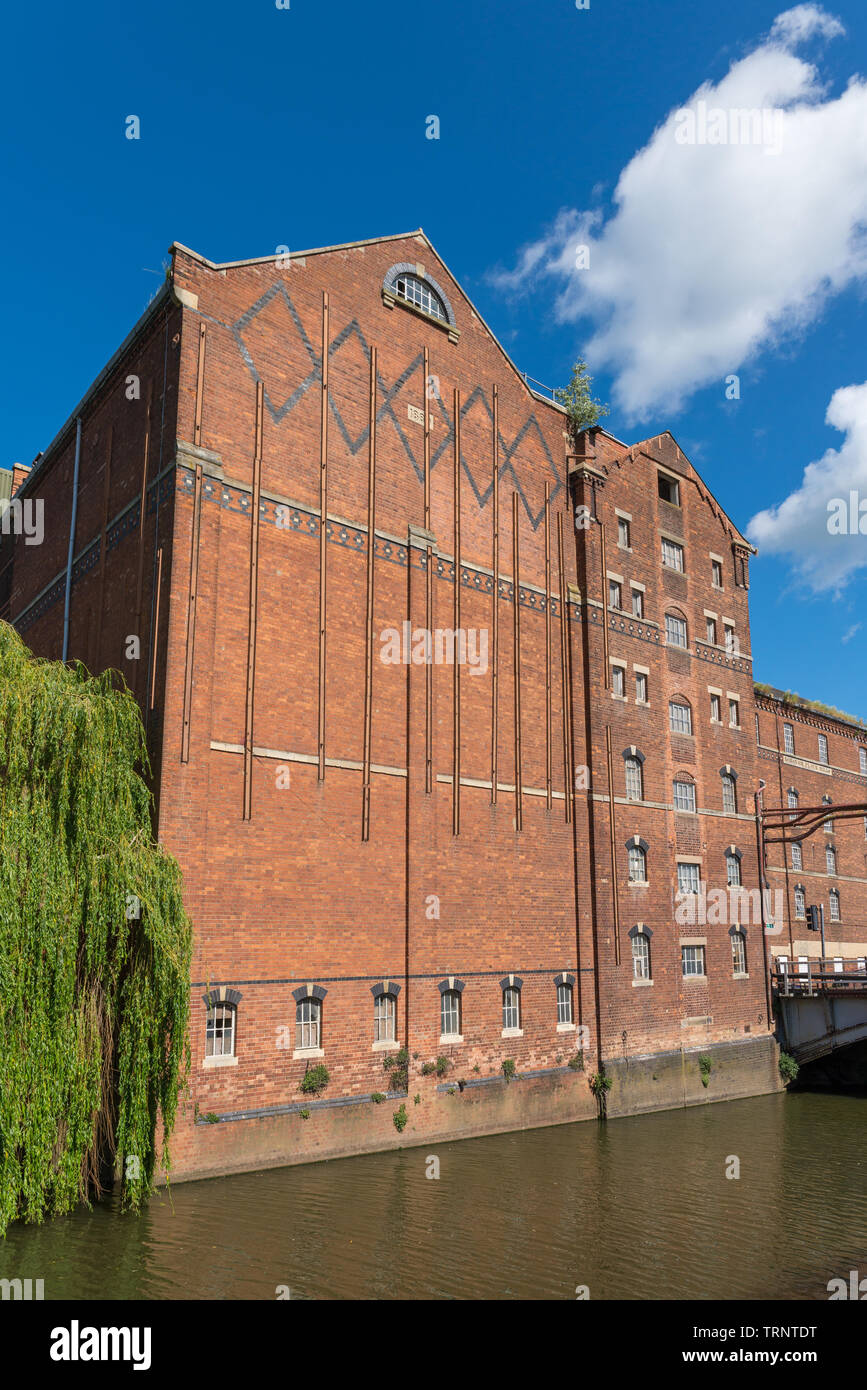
[0,0,867,717]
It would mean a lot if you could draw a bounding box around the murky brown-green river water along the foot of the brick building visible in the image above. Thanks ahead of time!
[0,1091,867,1300]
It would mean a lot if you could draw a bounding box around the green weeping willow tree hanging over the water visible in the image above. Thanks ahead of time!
[0,621,192,1234]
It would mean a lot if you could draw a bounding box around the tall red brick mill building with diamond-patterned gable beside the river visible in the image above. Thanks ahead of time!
[0,231,867,1175]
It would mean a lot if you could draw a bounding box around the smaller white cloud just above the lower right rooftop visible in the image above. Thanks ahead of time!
[746,382,867,592]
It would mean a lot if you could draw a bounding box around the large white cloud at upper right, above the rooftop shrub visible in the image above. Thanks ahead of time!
[495,4,867,421]
